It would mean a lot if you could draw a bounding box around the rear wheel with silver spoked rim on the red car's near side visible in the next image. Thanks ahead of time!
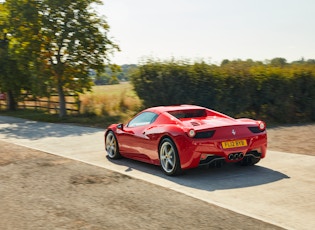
[159,138,182,176]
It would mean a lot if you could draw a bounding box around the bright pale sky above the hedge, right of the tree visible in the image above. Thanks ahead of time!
[99,0,315,64]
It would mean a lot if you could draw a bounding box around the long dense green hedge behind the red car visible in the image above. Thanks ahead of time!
[131,61,315,123]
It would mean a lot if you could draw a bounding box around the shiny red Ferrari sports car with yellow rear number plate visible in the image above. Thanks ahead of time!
[105,105,267,175]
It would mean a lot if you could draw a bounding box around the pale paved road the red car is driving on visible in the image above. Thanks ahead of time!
[0,116,315,230]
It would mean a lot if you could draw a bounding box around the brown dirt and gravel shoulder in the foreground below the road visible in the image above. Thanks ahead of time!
[0,141,280,230]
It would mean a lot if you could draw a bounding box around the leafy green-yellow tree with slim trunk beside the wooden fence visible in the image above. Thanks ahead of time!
[2,0,119,117]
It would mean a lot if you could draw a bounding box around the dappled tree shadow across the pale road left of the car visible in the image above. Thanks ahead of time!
[0,116,102,140]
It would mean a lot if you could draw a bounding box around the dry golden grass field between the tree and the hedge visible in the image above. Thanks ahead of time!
[80,82,141,117]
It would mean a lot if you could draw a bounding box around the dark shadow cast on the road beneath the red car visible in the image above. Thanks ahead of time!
[109,159,290,191]
